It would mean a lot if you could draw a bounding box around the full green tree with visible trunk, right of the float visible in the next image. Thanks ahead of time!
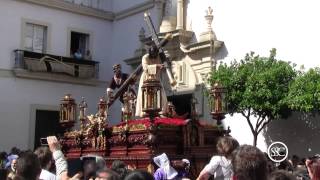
[209,49,297,146]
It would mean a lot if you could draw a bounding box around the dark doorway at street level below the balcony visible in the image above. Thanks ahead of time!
[34,110,60,149]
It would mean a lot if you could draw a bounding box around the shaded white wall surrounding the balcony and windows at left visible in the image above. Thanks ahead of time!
[0,0,112,151]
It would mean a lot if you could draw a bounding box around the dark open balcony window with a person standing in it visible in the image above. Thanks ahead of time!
[70,31,90,59]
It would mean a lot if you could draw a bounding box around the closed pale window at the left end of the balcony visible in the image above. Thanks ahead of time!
[24,23,48,53]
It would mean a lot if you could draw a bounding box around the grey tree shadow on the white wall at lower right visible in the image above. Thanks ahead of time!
[264,112,320,157]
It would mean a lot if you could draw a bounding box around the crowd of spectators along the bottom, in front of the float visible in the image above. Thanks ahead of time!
[0,136,320,180]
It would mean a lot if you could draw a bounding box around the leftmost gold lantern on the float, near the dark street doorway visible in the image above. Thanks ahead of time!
[60,94,77,123]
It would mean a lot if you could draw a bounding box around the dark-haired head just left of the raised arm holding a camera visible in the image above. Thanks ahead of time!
[34,146,53,170]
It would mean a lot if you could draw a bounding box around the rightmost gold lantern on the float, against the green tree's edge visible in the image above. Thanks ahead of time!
[210,83,227,125]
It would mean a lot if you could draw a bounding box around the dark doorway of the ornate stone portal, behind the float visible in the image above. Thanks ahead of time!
[168,94,192,118]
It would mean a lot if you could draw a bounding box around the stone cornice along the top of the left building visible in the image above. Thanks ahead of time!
[16,0,154,21]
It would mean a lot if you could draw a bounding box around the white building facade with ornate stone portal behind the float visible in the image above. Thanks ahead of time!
[0,0,320,155]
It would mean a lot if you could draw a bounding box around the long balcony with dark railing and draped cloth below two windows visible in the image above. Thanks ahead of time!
[14,49,99,86]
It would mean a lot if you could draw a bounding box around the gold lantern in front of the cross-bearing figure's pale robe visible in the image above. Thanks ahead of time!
[141,76,162,121]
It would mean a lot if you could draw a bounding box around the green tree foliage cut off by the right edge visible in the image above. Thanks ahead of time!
[286,68,320,114]
